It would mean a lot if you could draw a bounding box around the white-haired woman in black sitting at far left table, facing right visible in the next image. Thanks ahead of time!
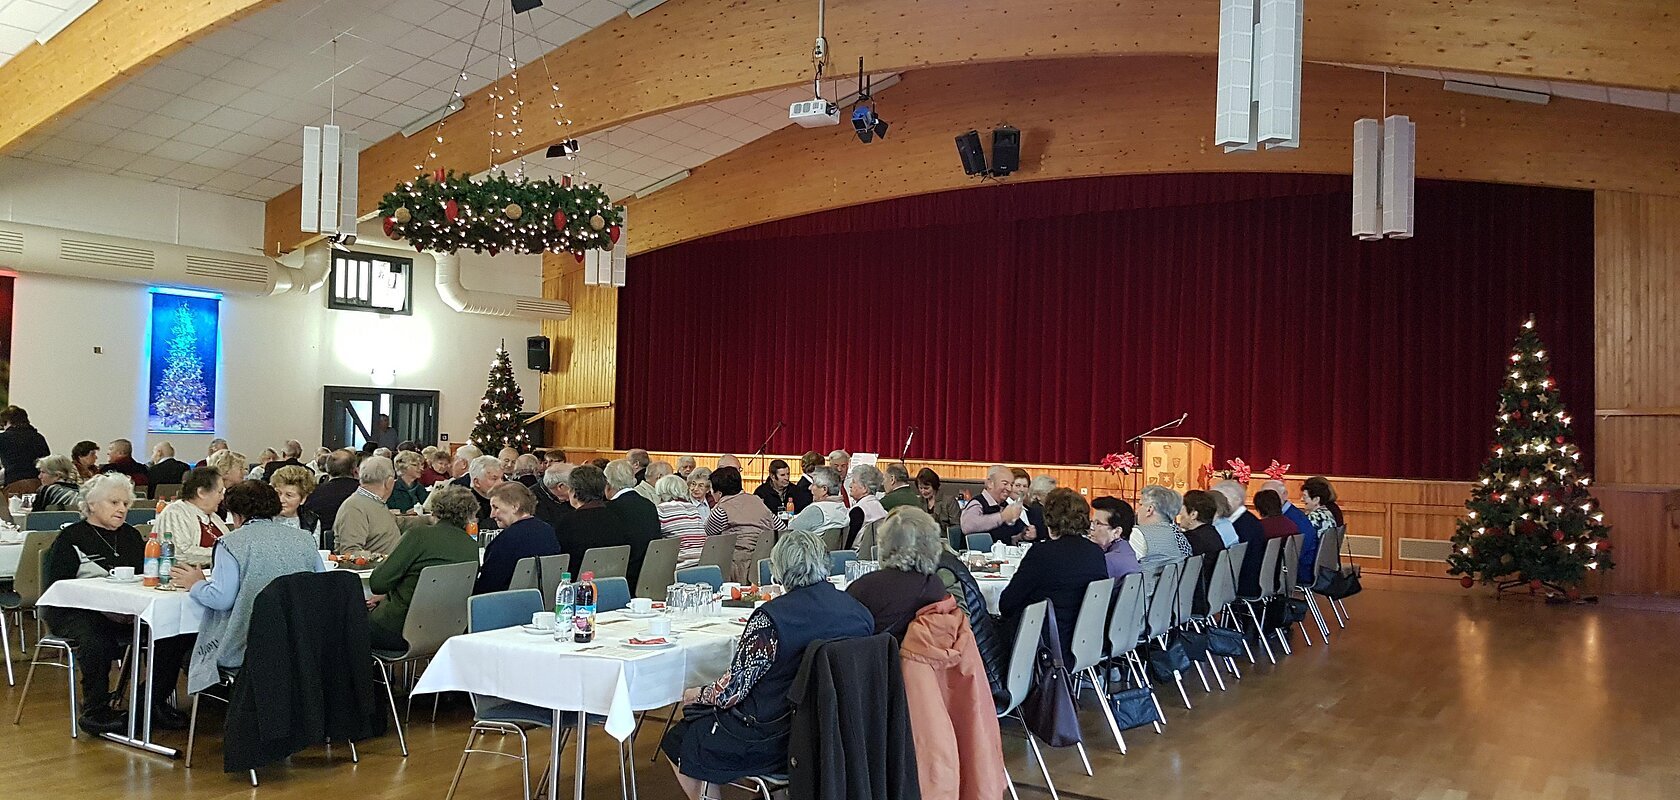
[40,472,193,734]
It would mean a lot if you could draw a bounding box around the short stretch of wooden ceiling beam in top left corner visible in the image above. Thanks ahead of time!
[0,0,276,153]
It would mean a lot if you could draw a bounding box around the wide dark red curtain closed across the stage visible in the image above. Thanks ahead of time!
[615,175,1593,479]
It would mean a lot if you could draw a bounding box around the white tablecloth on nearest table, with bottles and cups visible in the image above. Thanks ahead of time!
[415,608,735,739]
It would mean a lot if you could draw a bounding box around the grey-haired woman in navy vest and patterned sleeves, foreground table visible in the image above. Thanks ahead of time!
[660,527,875,800]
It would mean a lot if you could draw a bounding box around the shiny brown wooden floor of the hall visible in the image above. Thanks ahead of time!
[0,587,1680,800]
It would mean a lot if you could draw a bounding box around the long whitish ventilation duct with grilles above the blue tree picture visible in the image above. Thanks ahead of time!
[0,222,312,296]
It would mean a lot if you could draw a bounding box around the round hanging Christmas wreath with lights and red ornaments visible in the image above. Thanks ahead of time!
[380,170,625,261]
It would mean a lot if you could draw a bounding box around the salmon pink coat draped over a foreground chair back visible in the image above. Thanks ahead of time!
[899,597,1005,800]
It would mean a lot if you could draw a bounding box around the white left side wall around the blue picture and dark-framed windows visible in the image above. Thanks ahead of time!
[0,160,541,457]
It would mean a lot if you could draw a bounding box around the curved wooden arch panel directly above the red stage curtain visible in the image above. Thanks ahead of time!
[628,59,1680,252]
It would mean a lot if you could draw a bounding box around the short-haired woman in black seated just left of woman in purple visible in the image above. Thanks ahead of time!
[998,489,1109,662]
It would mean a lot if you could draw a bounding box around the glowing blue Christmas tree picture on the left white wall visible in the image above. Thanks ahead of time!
[146,289,222,434]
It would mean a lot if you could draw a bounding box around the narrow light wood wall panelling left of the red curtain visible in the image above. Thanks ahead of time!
[541,255,618,447]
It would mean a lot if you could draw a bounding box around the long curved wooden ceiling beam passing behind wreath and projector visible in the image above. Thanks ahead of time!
[264,0,1680,250]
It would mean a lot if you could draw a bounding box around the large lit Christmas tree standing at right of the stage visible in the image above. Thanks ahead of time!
[1446,318,1613,598]
